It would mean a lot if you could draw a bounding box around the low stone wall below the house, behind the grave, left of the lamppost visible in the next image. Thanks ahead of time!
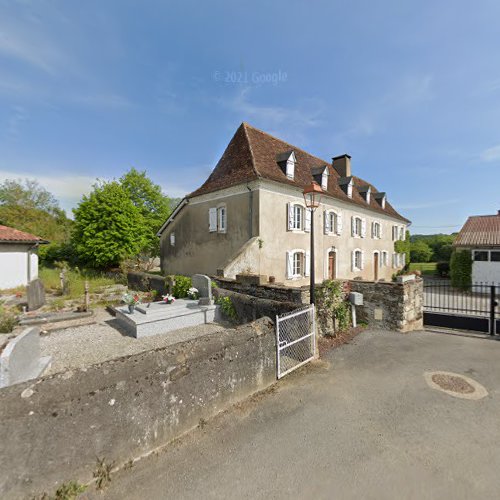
[212,277,310,304]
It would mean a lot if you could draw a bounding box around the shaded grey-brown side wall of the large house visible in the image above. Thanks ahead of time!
[160,186,259,276]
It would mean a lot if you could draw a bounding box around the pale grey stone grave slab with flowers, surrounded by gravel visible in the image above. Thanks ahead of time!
[115,299,219,338]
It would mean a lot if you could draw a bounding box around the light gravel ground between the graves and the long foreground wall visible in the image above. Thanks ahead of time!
[40,309,227,375]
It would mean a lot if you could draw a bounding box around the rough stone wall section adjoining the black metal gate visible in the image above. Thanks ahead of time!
[350,278,424,332]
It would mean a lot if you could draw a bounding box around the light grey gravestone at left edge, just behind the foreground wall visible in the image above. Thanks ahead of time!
[0,327,50,387]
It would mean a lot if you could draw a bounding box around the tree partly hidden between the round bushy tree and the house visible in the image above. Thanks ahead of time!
[120,168,172,256]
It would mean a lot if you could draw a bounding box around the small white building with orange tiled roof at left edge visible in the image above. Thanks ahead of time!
[0,225,47,290]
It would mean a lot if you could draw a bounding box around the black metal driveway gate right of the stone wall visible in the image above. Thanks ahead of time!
[424,282,500,335]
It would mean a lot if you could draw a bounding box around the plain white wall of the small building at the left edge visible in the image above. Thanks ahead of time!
[0,243,38,290]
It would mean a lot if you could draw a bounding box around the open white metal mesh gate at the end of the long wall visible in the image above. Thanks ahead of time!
[276,304,316,378]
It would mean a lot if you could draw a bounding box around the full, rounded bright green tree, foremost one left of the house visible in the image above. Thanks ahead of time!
[72,181,149,268]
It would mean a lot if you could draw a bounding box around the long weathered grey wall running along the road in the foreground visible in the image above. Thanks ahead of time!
[0,318,276,498]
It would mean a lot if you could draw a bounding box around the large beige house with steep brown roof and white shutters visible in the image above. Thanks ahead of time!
[158,123,409,286]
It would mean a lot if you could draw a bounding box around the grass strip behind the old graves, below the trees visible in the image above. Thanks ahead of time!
[38,267,123,299]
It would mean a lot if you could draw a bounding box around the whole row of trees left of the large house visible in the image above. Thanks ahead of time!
[0,168,179,269]
